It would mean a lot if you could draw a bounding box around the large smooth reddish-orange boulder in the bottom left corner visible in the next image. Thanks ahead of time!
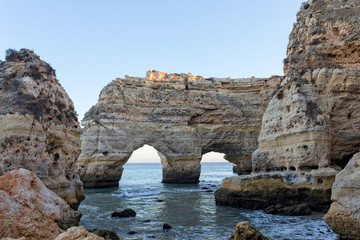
[0,168,81,239]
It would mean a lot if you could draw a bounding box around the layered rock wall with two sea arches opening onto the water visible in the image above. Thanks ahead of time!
[77,71,281,187]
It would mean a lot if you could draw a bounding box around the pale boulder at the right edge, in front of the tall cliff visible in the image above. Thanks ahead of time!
[325,153,360,239]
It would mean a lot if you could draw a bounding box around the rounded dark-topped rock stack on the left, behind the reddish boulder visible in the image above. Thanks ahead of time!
[0,49,83,209]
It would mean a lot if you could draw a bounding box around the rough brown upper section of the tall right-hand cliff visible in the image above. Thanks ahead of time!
[284,0,360,75]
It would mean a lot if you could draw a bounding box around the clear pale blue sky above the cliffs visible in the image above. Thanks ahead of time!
[0,0,303,162]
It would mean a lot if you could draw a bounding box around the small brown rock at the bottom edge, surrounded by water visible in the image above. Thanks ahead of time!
[229,222,269,240]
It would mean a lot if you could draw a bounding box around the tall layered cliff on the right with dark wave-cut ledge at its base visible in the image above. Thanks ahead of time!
[216,0,360,210]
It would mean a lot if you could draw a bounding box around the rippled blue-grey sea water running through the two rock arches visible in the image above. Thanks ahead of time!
[79,162,337,240]
